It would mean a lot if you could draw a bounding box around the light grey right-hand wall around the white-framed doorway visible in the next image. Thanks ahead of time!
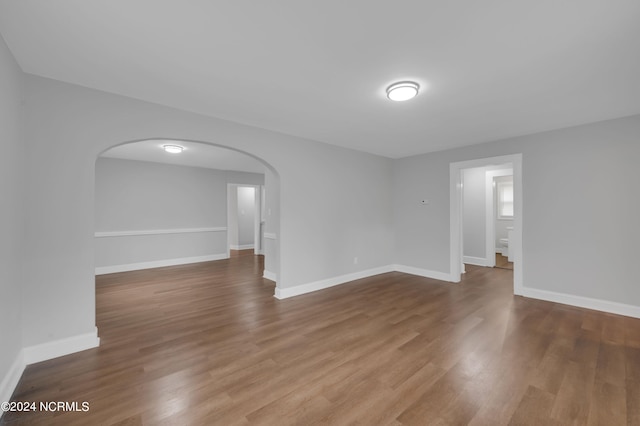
[393,116,640,306]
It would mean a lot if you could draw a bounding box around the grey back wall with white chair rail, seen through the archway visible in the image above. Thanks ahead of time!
[95,158,264,271]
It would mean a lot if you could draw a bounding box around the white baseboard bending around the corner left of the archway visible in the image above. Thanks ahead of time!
[0,328,100,403]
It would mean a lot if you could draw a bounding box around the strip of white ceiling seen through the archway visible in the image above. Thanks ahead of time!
[101,140,265,173]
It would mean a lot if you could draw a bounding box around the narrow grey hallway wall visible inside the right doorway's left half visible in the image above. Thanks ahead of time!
[462,168,486,263]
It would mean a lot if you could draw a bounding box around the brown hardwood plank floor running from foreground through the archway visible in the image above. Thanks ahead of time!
[1,255,640,426]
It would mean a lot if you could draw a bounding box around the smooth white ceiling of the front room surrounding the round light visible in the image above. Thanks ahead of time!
[0,0,640,158]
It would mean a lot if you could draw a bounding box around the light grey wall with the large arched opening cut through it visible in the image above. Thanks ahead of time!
[24,75,393,345]
